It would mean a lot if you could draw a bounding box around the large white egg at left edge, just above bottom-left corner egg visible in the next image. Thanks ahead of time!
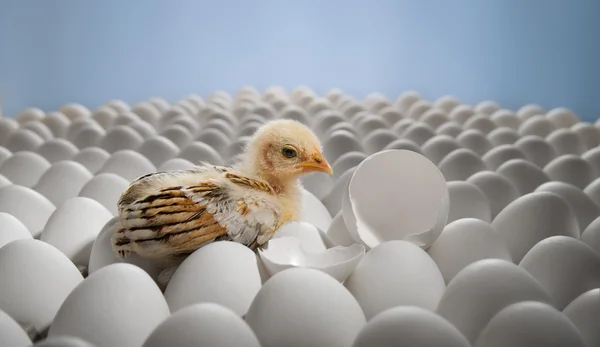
[0,239,83,332]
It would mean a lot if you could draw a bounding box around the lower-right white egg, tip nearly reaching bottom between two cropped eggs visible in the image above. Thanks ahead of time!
[436,257,552,342]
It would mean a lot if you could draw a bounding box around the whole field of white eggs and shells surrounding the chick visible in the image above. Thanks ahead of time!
[0,86,600,347]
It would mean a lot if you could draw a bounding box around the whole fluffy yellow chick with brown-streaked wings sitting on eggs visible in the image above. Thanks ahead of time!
[112,120,333,274]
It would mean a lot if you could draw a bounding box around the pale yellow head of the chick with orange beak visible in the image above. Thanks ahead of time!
[246,119,333,180]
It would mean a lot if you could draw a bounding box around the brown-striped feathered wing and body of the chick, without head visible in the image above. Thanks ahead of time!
[113,167,281,258]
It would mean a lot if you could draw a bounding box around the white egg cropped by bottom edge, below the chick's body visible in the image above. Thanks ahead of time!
[142,303,260,347]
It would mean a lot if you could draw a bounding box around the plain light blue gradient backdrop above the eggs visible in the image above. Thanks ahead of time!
[0,0,600,120]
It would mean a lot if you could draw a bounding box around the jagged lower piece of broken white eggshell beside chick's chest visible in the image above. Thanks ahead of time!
[259,236,365,282]
